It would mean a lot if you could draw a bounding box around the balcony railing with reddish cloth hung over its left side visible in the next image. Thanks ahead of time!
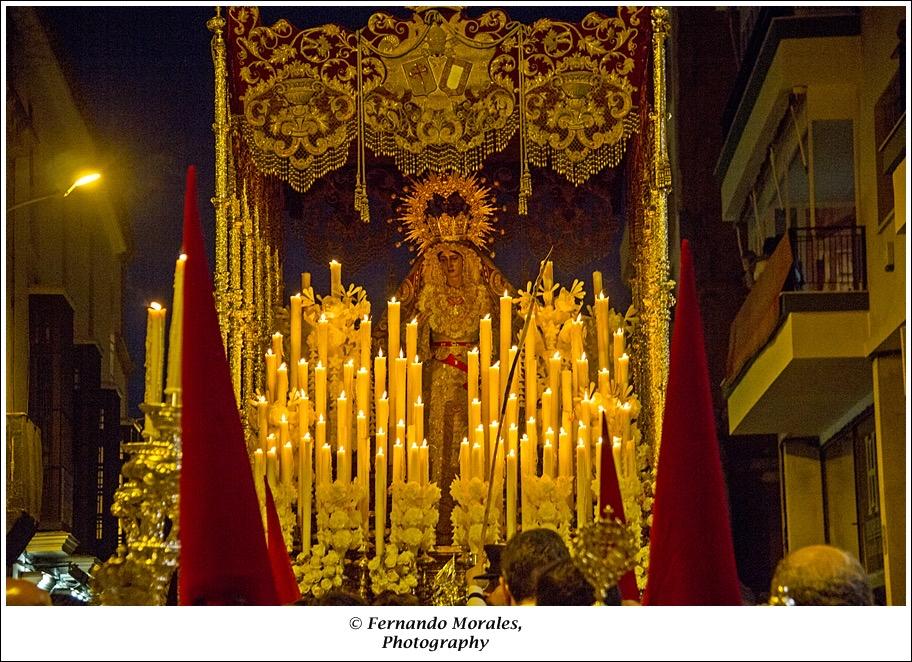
[724,225,867,390]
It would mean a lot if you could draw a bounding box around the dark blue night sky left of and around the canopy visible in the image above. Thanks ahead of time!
[32,4,626,415]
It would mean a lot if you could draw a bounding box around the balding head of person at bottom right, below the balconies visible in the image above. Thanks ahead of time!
[770,545,874,605]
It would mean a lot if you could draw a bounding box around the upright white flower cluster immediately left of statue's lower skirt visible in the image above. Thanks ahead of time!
[390,481,440,553]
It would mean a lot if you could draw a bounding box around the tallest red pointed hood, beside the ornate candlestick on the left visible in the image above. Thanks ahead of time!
[179,166,278,605]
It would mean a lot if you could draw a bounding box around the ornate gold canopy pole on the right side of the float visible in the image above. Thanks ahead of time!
[641,7,674,464]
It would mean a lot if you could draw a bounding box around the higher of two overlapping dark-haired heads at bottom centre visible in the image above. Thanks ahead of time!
[500,529,570,605]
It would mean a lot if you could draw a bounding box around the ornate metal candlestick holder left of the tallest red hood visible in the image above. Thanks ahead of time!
[92,397,181,605]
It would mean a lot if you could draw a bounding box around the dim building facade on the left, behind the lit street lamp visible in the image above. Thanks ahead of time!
[5,7,130,596]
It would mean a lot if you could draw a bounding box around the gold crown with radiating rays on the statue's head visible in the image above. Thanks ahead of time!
[399,173,496,255]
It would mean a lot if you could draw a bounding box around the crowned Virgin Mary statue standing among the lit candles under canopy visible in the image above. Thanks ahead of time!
[396,174,515,543]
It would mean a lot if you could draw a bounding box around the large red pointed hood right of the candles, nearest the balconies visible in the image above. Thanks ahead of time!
[643,241,741,605]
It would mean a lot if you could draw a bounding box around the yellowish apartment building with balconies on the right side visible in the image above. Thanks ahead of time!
[716,7,907,604]
